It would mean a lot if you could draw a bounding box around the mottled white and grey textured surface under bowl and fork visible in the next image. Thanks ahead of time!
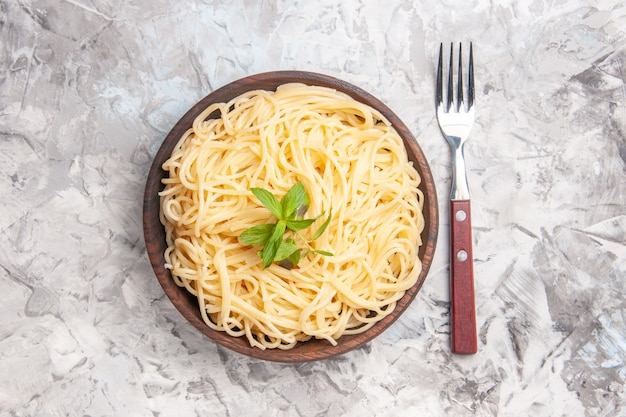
[0,0,626,417]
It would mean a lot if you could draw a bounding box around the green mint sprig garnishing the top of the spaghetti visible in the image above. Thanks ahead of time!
[239,182,333,269]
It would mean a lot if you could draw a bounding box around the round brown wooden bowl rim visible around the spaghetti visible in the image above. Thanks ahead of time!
[143,71,438,362]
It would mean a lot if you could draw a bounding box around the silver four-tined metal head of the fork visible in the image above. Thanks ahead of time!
[437,42,474,147]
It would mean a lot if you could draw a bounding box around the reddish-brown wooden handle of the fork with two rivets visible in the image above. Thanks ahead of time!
[450,200,478,354]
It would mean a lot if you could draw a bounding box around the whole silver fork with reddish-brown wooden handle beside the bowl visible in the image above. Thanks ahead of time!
[437,42,478,354]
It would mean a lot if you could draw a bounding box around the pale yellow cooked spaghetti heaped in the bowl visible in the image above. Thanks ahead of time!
[160,84,424,349]
